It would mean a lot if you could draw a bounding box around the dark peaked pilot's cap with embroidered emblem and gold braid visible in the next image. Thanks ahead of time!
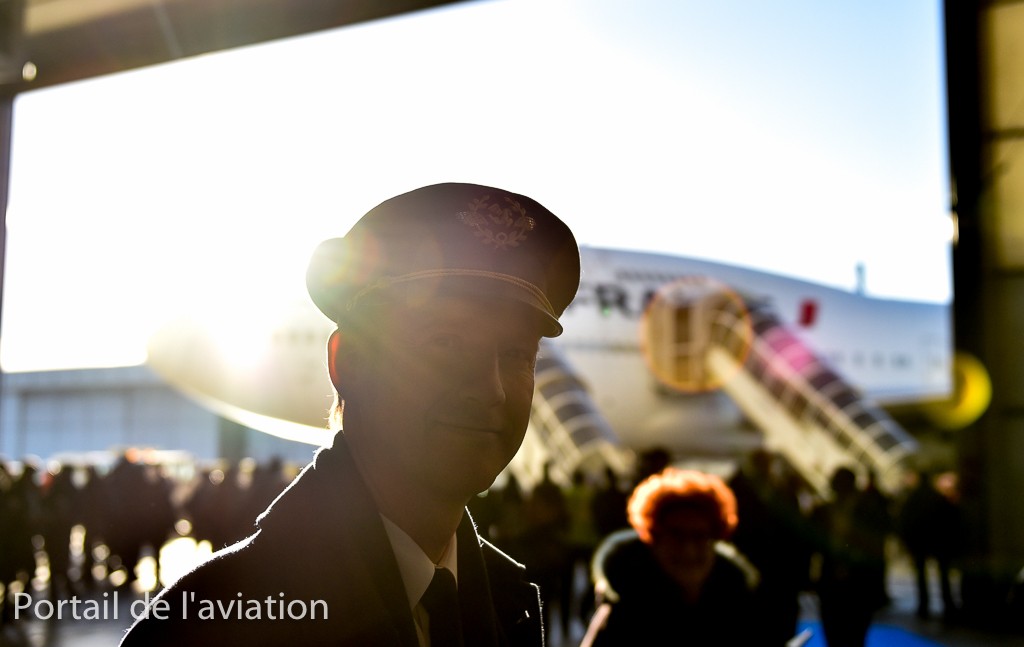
[306,183,580,337]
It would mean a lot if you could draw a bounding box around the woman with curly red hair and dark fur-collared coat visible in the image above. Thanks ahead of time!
[583,468,757,647]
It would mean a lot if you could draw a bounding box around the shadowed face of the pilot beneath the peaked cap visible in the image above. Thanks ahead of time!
[342,297,541,499]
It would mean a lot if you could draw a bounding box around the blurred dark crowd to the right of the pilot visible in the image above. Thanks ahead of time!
[470,450,966,647]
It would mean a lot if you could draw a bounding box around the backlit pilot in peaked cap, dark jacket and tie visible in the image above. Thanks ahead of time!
[122,183,580,647]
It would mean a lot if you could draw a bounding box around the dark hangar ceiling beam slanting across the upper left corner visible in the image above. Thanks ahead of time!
[11,0,468,92]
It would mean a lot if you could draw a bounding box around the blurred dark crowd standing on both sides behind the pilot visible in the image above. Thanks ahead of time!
[0,442,965,647]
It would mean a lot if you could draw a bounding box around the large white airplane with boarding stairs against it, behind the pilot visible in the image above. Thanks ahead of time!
[147,246,953,492]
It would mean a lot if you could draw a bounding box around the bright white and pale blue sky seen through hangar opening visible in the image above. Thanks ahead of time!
[0,0,951,371]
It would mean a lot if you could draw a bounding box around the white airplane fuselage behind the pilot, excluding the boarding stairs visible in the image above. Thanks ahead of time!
[150,247,951,455]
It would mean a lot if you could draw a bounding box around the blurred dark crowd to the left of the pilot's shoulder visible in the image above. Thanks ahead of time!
[0,450,289,623]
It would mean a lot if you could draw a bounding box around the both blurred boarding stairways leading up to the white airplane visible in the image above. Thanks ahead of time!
[517,282,918,497]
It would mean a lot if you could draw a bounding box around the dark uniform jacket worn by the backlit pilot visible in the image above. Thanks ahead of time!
[121,434,544,647]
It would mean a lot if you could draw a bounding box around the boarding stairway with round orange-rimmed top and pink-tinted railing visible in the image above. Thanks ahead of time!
[646,287,918,495]
